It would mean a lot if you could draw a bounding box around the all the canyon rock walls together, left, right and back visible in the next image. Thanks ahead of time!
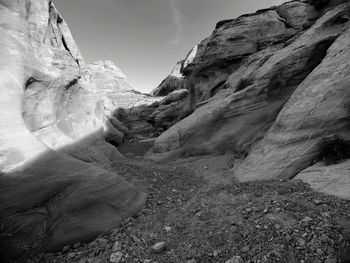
[0,0,350,260]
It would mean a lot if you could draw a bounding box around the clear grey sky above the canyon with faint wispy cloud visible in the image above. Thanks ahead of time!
[54,0,286,92]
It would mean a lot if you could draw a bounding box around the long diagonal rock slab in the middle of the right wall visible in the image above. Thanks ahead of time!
[150,0,346,155]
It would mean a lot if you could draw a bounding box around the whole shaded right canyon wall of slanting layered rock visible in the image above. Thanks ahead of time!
[148,1,350,198]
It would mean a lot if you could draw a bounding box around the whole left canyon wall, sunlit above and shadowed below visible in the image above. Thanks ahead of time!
[0,0,145,260]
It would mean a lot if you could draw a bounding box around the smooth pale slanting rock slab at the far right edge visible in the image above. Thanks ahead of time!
[236,21,350,184]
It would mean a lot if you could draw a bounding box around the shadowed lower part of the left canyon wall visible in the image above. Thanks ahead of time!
[0,131,146,262]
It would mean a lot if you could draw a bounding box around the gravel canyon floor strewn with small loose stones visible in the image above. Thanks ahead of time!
[24,156,350,263]
